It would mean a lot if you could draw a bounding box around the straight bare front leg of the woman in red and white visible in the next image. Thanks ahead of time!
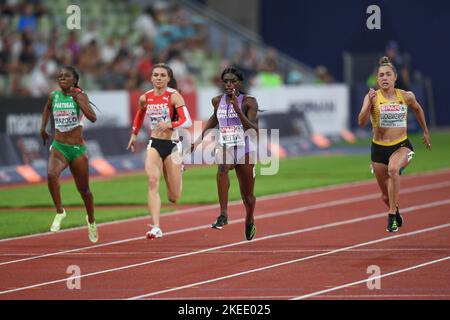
[145,148,162,227]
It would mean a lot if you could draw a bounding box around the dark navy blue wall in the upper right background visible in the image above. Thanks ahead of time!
[260,0,450,126]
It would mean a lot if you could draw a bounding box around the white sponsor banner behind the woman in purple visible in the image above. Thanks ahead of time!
[198,84,350,135]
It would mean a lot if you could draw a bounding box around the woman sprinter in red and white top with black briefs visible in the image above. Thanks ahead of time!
[127,63,192,239]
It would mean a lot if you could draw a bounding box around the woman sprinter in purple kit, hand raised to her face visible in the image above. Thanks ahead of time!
[191,67,258,240]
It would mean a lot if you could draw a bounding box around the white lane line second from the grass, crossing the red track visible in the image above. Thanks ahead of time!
[0,181,450,266]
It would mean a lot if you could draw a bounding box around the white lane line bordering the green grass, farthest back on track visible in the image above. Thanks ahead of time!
[0,169,450,243]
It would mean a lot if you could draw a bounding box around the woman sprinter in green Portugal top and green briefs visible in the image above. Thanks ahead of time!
[41,66,98,243]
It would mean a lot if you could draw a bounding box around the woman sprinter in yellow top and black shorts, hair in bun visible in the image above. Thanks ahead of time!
[358,57,431,232]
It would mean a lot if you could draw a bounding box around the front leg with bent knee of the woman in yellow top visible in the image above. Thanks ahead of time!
[388,148,411,214]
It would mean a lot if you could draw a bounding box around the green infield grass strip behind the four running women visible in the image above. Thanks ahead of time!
[0,131,450,238]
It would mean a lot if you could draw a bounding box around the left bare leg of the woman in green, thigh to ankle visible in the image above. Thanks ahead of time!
[47,147,69,213]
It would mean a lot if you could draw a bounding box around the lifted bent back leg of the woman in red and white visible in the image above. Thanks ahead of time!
[163,152,183,203]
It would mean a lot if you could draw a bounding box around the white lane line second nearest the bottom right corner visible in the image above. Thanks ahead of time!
[128,223,450,300]
